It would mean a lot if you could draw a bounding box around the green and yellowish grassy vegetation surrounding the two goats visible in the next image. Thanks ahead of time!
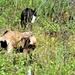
[0,0,75,75]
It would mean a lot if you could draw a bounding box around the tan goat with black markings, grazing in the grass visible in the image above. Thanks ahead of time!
[0,30,36,54]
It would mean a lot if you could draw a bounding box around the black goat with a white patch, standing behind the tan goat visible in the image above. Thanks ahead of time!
[21,8,36,30]
